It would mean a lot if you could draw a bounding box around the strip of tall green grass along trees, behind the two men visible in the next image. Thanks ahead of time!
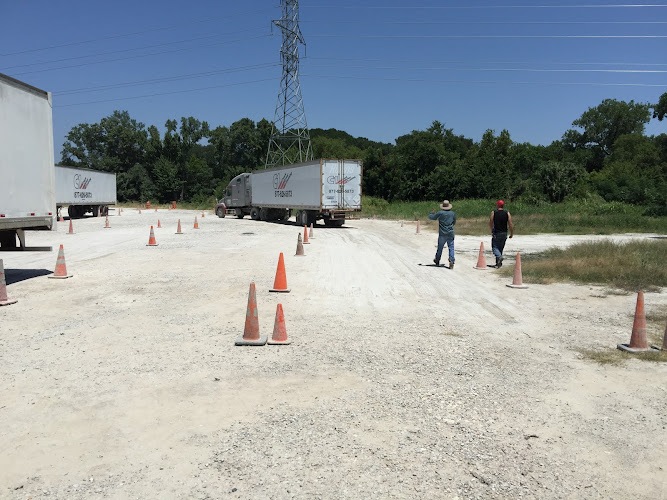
[362,196,667,235]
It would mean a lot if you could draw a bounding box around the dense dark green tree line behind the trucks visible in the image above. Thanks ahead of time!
[61,93,667,215]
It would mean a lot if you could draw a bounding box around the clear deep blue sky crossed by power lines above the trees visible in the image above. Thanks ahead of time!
[0,0,667,159]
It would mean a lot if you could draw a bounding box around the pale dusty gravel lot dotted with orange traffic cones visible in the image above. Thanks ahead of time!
[0,209,667,500]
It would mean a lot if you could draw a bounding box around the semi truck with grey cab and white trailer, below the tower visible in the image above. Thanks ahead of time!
[222,159,363,227]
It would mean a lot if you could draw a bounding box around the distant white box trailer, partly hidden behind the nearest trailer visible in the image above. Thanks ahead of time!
[56,165,116,219]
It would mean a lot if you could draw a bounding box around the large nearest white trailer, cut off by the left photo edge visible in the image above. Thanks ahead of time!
[0,73,56,251]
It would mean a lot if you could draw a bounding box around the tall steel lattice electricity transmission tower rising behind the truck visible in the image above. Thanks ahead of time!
[265,0,313,168]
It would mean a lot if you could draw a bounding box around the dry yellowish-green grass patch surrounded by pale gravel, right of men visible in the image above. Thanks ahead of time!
[504,240,667,292]
